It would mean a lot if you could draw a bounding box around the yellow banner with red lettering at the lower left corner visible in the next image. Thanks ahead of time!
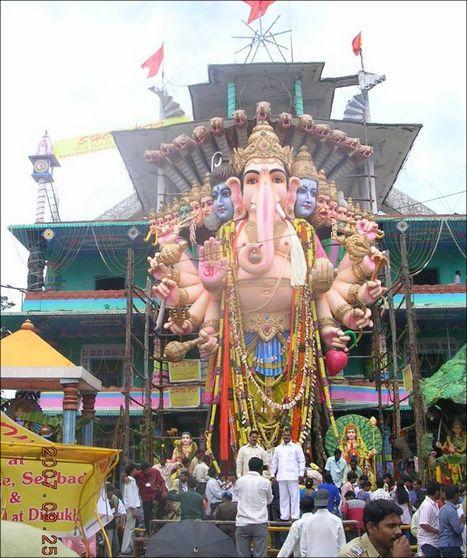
[0,413,119,546]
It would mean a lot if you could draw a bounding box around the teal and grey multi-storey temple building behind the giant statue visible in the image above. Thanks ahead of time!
[1,62,466,464]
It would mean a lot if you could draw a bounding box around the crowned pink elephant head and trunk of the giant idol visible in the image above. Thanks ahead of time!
[227,122,300,275]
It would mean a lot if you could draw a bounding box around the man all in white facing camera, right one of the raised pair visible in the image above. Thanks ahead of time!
[271,429,305,521]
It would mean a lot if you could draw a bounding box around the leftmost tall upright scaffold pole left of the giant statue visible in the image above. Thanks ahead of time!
[122,248,134,465]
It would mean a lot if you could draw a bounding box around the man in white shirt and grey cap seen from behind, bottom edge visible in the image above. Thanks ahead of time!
[300,489,345,557]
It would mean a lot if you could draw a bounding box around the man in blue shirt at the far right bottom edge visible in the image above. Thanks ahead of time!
[438,486,465,558]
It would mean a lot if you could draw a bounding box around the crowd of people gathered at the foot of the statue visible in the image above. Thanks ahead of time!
[97,430,466,558]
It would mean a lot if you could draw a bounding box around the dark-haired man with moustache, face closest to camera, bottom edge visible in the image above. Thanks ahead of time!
[338,500,412,558]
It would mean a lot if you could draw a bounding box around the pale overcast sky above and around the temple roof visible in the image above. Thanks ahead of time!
[1,0,466,311]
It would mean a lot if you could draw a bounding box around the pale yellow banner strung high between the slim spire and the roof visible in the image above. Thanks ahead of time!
[53,116,189,158]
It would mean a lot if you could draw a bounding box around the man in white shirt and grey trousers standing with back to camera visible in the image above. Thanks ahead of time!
[235,457,273,558]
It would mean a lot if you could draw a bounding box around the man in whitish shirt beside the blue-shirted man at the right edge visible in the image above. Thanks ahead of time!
[418,481,441,558]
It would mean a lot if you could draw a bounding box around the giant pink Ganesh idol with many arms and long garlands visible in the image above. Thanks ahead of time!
[151,119,384,462]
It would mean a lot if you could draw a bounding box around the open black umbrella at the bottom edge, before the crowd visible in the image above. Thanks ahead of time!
[145,519,237,558]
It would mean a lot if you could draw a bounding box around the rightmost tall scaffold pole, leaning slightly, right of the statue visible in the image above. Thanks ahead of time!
[400,233,425,482]
